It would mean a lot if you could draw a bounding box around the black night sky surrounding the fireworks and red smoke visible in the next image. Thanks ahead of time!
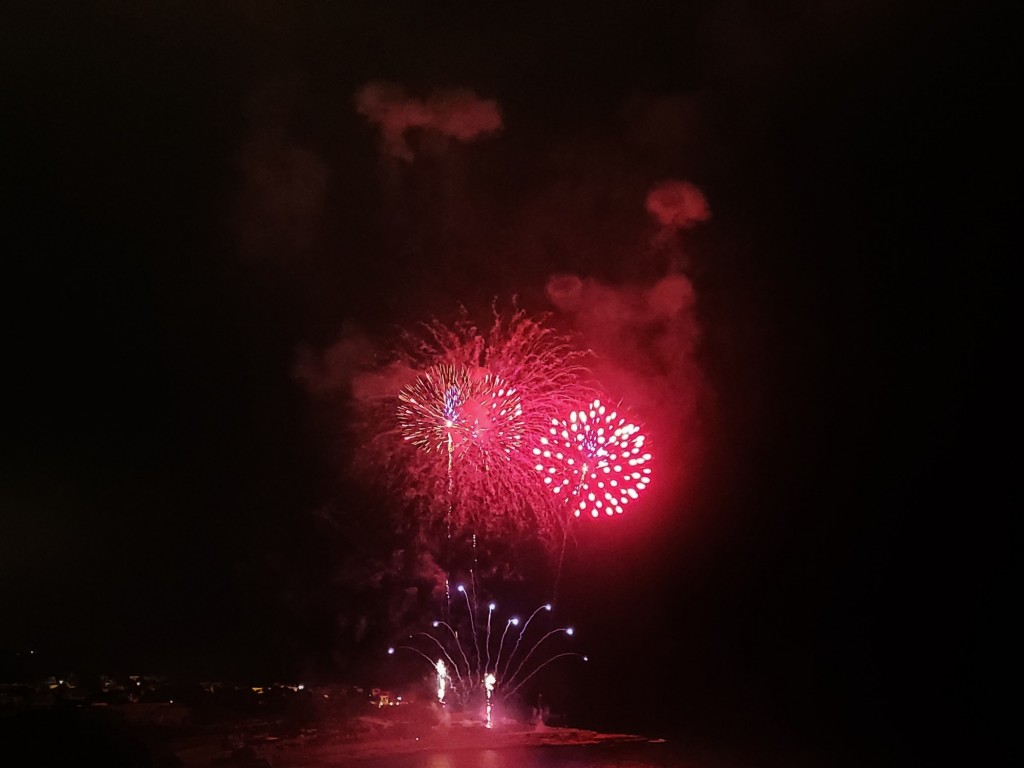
[0,0,1013,764]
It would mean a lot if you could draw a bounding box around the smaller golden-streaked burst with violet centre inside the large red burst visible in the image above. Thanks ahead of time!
[397,364,525,459]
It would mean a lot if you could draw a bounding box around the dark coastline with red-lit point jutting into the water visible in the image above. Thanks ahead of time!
[0,701,663,768]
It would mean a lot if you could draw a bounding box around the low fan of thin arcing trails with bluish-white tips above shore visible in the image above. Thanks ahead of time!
[388,585,587,727]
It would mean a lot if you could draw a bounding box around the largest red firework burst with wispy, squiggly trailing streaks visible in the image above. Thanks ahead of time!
[354,303,593,551]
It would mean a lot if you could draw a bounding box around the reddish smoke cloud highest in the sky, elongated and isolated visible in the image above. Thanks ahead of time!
[355,82,502,162]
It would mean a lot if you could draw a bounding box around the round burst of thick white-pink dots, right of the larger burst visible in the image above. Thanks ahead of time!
[532,398,651,517]
